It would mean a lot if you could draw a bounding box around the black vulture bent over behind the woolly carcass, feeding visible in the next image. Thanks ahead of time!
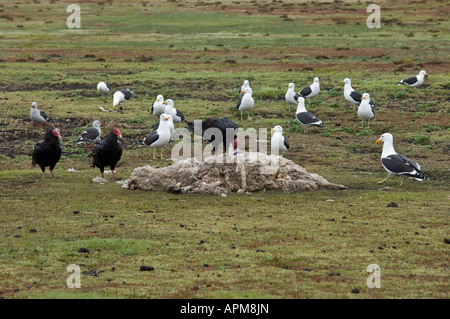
[186,118,239,153]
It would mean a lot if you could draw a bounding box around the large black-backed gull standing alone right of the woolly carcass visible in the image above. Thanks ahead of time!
[376,133,429,185]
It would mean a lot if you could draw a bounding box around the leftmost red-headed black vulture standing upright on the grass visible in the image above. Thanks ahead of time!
[31,128,62,179]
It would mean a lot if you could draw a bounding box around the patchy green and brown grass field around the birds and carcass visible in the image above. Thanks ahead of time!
[0,0,450,298]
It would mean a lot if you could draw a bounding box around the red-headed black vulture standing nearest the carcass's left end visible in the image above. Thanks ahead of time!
[92,128,122,178]
